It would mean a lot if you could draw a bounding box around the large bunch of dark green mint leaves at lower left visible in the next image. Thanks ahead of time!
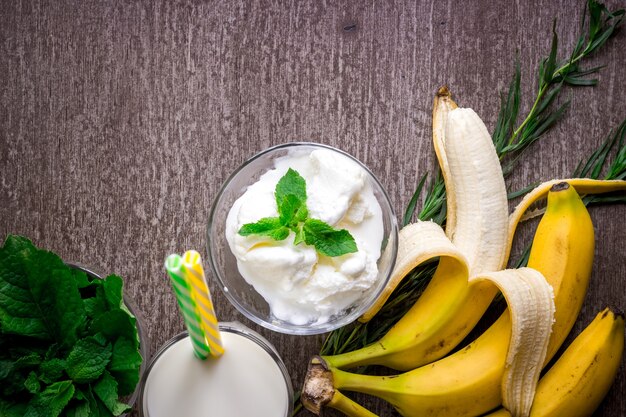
[0,236,142,417]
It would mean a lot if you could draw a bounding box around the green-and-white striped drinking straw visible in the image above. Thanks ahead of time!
[165,254,209,360]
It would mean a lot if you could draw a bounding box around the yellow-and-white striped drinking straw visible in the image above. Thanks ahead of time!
[183,250,224,357]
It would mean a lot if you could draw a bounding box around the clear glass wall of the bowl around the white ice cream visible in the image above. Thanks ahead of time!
[208,142,398,335]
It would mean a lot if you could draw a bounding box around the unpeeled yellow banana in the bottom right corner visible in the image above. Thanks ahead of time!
[482,308,624,417]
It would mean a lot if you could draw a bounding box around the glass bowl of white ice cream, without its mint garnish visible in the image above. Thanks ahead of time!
[208,143,398,335]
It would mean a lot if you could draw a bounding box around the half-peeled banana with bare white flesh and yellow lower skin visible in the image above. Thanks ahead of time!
[324,87,508,370]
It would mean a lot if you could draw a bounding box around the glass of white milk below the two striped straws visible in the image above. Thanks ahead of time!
[139,322,293,417]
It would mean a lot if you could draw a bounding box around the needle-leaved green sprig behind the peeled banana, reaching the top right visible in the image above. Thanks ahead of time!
[404,0,624,228]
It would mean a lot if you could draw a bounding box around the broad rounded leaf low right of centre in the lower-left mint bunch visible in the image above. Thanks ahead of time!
[65,336,111,384]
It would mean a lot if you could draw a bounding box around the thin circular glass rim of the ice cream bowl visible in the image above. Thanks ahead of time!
[207,142,398,336]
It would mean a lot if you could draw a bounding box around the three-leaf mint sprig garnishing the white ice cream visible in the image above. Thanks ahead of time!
[239,168,357,257]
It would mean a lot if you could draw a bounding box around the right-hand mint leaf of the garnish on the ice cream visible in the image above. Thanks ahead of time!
[303,219,357,257]
